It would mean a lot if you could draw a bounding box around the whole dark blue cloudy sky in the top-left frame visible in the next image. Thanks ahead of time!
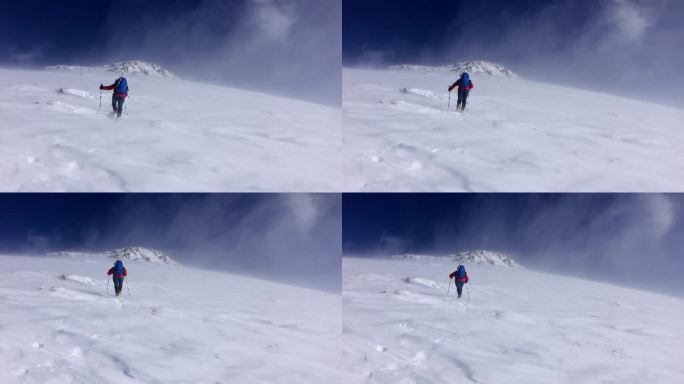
[0,0,342,104]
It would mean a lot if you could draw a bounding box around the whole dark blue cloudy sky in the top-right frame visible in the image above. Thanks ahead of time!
[342,0,684,107]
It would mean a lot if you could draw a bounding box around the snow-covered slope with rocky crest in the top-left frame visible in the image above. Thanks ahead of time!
[0,62,342,192]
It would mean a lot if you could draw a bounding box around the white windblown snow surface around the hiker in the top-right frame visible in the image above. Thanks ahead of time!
[342,68,684,192]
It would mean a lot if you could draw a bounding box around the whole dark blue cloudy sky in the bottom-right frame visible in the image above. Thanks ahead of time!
[342,194,684,295]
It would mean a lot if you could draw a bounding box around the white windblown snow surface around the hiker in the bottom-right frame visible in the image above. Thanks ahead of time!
[342,257,684,384]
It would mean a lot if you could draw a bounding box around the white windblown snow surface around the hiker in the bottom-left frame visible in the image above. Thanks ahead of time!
[0,256,342,384]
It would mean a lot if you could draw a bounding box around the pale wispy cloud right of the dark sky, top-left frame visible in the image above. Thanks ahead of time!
[97,0,342,106]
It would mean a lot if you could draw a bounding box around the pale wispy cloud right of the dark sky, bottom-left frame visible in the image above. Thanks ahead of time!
[78,194,341,291]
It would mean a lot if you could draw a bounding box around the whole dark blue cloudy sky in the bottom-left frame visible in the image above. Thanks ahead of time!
[0,193,341,292]
